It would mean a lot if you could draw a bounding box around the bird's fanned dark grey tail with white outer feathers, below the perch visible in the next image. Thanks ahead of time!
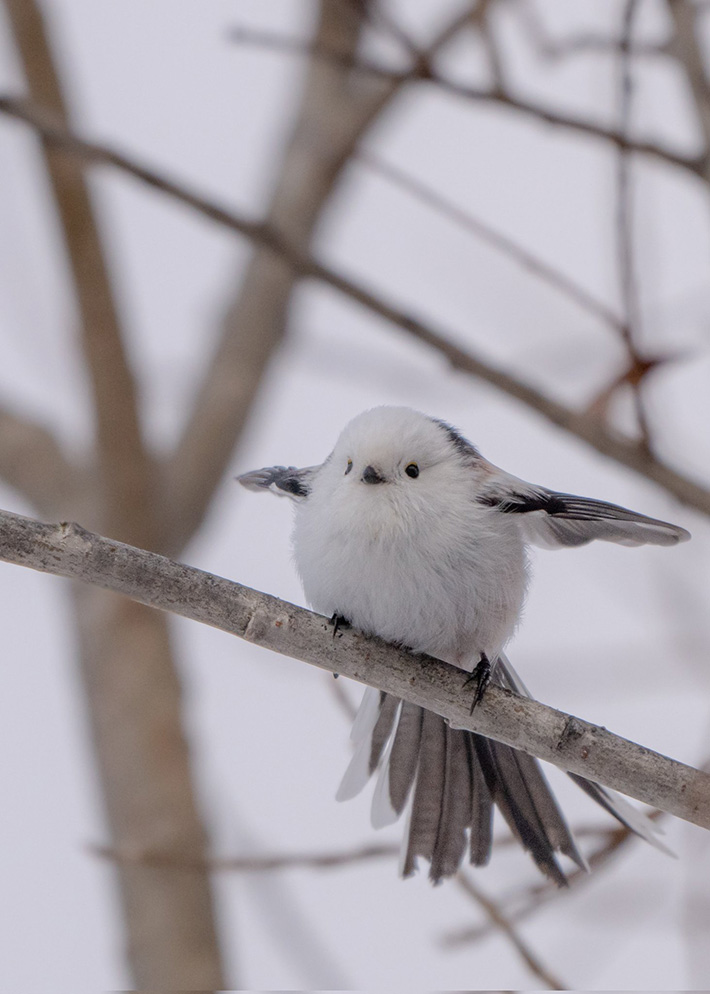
[337,657,668,886]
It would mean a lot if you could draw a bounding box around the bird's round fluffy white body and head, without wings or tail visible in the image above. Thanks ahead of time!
[293,408,527,670]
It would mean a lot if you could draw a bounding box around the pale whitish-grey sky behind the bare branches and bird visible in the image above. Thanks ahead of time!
[0,0,710,990]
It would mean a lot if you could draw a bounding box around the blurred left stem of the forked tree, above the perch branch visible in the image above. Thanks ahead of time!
[5,0,153,546]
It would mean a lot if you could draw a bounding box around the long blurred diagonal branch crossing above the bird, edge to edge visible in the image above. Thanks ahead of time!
[0,96,710,514]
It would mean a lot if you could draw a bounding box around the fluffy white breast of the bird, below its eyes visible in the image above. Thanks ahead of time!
[293,485,527,669]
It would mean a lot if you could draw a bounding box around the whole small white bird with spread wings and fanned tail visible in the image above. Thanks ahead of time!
[239,407,690,885]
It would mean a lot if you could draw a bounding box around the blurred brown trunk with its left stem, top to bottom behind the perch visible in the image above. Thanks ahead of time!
[5,0,225,989]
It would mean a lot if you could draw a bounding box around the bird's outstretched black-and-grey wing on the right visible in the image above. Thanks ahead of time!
[478,469,690,549]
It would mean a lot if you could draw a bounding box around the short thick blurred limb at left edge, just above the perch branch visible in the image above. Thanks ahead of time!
[0,408,81,516]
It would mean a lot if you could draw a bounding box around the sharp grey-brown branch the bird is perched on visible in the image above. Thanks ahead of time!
[0,511,710,828]
